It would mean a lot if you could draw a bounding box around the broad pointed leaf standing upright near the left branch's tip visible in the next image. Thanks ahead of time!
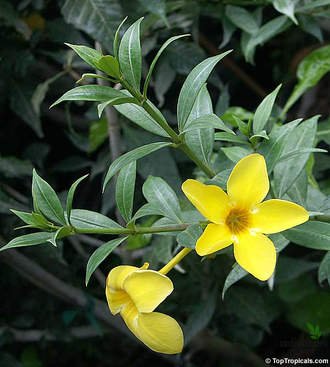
[32,170,66,226]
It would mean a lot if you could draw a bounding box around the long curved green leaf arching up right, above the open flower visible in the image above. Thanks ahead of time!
[178,51,231,131]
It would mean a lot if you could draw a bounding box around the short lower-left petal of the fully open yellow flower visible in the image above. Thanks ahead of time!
[196,224,233,256]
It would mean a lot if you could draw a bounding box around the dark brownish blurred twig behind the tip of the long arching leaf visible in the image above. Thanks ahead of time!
[199,34,268,99]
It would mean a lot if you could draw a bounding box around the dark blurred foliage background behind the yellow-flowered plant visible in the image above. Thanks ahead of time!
[0,0,330,367]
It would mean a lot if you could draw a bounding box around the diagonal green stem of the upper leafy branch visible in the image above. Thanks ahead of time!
[120,80,215,178]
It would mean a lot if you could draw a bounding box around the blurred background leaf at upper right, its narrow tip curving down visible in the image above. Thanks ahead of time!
[244,15,292,62]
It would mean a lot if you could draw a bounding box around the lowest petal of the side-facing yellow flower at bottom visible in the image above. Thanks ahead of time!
[137,312,183,354]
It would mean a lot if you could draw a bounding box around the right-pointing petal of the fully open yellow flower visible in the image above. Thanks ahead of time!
[252,199,309,234]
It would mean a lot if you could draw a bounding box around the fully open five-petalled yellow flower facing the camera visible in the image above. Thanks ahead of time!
[182,154,309,280]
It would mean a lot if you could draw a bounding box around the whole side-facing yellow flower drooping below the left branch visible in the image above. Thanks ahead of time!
[106,263,183,354]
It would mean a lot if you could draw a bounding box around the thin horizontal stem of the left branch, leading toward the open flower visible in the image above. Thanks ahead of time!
[75,224,189,235]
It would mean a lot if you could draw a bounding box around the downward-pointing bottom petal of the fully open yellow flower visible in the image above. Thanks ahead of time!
[234,233,276,280]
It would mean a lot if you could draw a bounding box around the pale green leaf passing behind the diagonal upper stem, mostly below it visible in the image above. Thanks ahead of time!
[115,91,169,138]
